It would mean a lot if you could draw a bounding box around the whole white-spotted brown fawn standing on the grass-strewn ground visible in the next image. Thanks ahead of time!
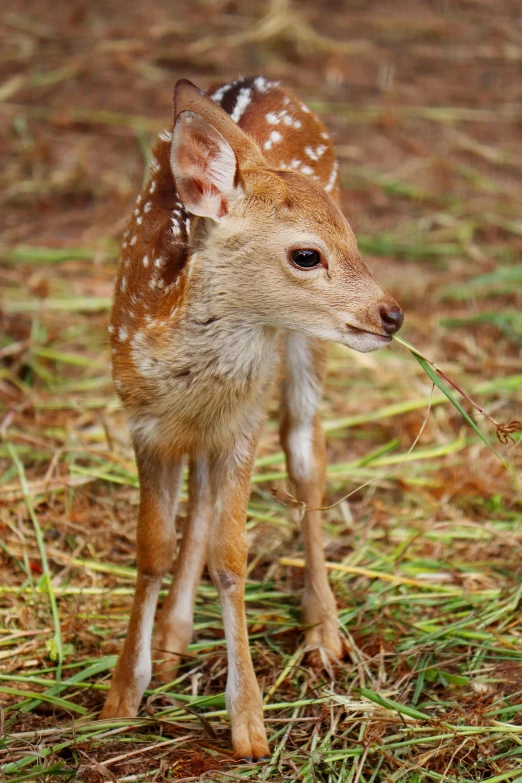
[100,76,403,761]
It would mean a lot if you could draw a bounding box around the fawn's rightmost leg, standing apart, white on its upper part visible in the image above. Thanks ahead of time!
[281,333,343,664]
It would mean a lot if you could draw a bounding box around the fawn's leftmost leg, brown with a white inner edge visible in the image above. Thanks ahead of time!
[100,449,183,719]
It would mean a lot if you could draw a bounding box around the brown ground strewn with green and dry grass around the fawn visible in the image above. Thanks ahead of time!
[0,0,522,783]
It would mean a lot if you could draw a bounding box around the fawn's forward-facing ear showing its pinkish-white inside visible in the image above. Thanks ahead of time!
[170,111,243,221]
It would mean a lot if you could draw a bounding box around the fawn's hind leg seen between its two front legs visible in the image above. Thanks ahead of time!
[152,458,212,682]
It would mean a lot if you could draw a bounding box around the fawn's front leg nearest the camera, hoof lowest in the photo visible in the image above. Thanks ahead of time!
[207,443,269,760]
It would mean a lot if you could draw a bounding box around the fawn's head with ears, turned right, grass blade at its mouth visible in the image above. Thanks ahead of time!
[171,80,403,351]
